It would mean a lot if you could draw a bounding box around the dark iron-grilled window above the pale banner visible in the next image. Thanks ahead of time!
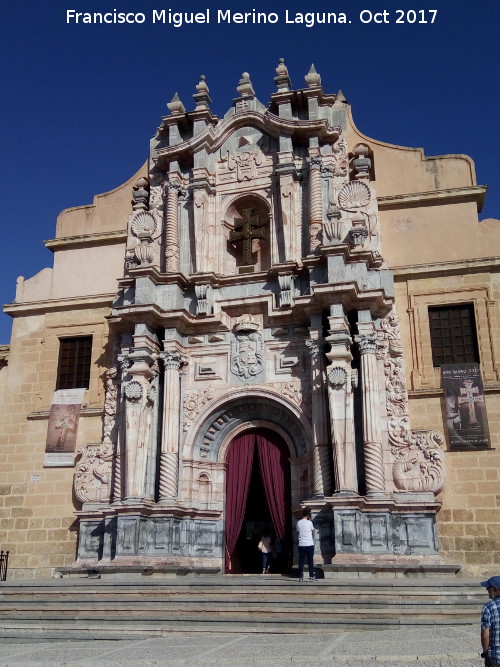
[56,336,92,389]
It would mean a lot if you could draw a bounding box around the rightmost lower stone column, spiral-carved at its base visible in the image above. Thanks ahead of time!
[355,332,385,496]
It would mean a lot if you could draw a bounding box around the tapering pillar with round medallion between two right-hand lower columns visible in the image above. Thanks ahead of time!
[326,304,358,495]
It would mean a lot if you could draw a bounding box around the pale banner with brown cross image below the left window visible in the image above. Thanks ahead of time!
[43,389,86,467]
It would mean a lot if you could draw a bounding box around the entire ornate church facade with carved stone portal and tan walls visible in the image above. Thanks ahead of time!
[0,61,500,578]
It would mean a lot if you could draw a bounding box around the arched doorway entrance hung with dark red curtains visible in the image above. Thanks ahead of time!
[225,429,291,574]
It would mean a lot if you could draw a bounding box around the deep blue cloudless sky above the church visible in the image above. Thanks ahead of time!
[0,0,500,344]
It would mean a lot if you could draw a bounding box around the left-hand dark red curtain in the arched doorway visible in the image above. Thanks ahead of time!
[226,433,255,572]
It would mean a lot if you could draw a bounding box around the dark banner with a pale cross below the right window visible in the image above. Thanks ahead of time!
[441,363,490,449]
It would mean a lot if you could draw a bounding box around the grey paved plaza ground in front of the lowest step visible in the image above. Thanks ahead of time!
[0,622,484,667]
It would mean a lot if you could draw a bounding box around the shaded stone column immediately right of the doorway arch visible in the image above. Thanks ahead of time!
[306,315,332,498]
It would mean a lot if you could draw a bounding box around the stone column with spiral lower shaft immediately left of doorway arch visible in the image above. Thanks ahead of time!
[159,349,186,501]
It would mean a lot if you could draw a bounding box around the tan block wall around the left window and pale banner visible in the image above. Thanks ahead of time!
[0,308,109,579]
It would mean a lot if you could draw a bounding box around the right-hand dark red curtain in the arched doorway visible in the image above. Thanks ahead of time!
[256,434,287,542]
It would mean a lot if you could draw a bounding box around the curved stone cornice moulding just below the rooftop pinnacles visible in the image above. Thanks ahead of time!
[153,111,341,163]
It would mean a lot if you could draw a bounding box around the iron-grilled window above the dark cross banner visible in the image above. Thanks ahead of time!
[429,303,479,367]
